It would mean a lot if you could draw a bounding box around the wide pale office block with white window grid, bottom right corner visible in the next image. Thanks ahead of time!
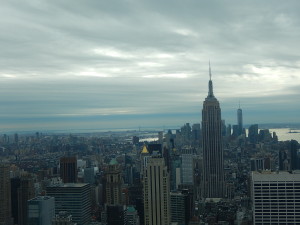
[251,171,300,224]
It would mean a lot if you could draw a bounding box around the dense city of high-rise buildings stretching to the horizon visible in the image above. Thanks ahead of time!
[0,66,300,225]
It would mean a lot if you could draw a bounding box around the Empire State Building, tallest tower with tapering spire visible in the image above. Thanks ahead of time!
[202,65,225,198]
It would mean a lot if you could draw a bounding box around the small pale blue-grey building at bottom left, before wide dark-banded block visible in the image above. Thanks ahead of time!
[28,196,55,225]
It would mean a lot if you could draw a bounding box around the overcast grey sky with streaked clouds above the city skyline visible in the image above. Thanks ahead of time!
[0,0,300,132]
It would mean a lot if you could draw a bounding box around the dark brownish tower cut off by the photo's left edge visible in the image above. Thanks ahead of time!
[0,164,11,225]
